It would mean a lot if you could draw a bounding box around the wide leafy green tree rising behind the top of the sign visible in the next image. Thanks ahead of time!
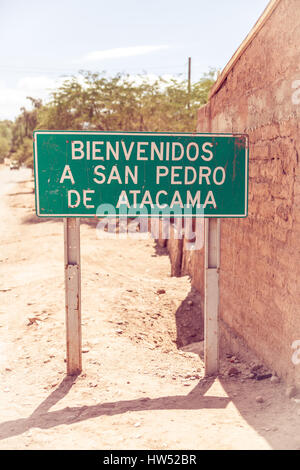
[11,70,215,167]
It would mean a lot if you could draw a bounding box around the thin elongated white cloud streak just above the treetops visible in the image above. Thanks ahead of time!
[76,45,169,62]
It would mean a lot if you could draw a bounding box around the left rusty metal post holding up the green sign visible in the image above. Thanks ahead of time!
[64,218,82,375]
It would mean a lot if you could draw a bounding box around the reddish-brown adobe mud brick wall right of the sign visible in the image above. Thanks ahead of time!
[197,0,300,386]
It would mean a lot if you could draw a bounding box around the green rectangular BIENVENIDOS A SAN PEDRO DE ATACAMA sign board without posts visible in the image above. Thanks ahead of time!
[34,131,248,217]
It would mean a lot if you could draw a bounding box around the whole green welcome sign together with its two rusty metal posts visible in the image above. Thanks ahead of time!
[33,130,248,375]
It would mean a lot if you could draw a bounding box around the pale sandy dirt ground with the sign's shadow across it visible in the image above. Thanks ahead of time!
[0,166,300,450]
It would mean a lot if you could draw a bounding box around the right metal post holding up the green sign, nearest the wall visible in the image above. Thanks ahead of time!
[204,218,220,376]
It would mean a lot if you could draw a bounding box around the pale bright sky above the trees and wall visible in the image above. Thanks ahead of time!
[0,0,269,120]
